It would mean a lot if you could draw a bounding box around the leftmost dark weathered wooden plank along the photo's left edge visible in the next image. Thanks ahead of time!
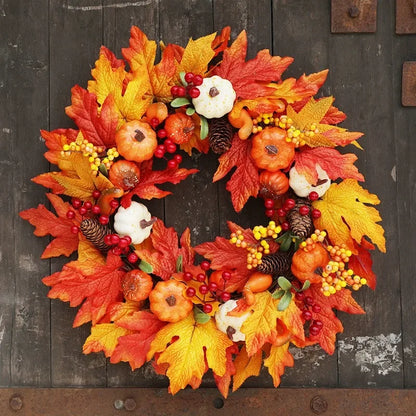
[0,1,50,386]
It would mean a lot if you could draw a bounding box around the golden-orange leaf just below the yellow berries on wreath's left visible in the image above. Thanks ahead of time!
[49,153,114,201]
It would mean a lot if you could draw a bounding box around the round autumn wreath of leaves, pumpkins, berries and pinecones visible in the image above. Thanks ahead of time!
[20,27,385,397]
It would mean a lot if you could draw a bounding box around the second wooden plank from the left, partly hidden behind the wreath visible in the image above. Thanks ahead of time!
[49,0,106,386]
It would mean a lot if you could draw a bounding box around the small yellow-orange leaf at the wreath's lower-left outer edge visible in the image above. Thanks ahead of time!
[82,324,132,357]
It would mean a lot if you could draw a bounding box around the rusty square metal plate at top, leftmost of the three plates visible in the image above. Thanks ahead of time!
[331,0,377,33]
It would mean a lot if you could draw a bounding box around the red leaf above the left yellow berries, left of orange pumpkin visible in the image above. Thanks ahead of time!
[65,85,118,148]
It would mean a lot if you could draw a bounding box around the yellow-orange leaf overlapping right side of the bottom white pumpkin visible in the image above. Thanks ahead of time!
[241,291,279,356]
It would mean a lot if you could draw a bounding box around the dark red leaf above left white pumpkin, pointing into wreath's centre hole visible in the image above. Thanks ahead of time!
[121,160,198,208]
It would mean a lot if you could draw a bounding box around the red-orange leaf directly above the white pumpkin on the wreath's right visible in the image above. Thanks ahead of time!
[295,146,364,184]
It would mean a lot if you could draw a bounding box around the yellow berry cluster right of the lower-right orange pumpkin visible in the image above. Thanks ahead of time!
[322,244,367,296]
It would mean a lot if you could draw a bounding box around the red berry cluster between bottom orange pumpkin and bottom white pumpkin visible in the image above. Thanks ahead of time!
[183,260,231,313]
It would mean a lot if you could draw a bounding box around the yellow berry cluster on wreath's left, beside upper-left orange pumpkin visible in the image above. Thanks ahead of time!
[61,135,119,171]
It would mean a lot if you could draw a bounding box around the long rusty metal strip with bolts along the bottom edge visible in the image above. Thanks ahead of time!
[0,388,416,416]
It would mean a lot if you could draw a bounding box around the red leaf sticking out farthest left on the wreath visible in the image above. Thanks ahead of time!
[19,194,82,259]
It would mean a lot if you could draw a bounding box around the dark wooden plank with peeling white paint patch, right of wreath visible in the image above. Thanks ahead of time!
[329,2,403,388]
